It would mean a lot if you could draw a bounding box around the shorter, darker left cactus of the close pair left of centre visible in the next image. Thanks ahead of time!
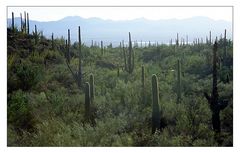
[85,82,91,120]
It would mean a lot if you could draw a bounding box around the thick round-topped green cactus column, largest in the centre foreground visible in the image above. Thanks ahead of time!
[152,74,160,133]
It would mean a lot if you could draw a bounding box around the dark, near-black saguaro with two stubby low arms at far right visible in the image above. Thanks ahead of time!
[204,40,228,133]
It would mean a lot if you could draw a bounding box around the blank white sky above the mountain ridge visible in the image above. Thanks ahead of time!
[8,7,232,22]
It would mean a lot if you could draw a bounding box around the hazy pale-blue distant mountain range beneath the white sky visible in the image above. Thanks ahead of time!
[8,16,232,45]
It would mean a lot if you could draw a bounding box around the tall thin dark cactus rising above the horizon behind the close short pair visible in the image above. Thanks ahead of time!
[78,26,82,88]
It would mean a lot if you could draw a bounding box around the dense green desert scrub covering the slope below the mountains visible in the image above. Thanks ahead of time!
[7,15,233,146]
